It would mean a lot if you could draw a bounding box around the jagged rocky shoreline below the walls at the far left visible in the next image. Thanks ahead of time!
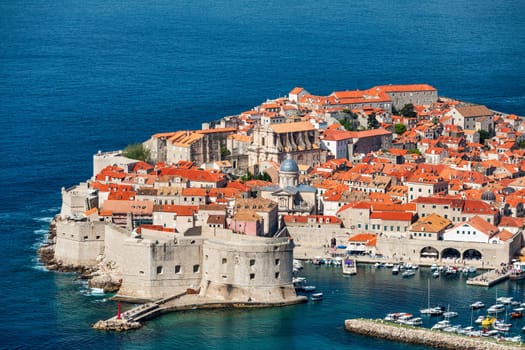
[38,217,122,293]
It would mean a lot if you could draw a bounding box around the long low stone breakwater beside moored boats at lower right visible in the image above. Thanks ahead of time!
[345,319,523,350]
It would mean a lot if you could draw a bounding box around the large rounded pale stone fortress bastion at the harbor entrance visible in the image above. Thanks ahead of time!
[200,235,296,302]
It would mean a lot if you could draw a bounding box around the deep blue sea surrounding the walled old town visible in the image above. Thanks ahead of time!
[0,0,525,349]
